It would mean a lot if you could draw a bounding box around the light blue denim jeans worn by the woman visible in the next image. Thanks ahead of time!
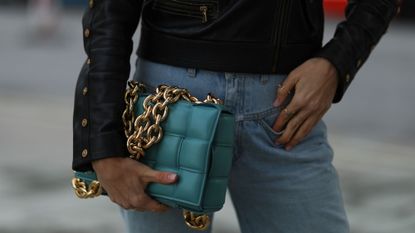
[122,59,349,233]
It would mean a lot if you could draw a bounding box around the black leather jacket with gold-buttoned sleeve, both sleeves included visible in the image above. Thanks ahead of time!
[73,0,398,170]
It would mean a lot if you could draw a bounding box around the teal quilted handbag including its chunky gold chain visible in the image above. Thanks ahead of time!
[72,81,234,229]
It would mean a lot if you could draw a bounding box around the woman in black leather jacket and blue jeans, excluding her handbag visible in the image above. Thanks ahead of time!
[73,0,398,233]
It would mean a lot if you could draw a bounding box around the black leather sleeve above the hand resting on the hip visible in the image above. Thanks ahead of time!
[317,0,399,103]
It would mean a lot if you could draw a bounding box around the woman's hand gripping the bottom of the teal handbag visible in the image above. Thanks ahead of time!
[92,157,177,212]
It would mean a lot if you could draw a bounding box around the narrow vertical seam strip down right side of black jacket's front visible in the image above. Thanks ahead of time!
[272,0,290,73]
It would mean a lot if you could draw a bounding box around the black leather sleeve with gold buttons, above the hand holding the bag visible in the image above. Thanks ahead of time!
[72,0,142,171]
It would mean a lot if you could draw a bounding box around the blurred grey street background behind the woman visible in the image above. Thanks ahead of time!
[0,0,415,233]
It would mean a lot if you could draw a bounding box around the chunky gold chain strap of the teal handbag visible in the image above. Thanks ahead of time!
[72,81,222,230]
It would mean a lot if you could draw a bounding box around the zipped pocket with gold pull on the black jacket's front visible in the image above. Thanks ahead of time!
[153,0,218,23]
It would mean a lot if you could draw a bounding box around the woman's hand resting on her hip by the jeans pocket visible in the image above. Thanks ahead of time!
[273,58,338,150]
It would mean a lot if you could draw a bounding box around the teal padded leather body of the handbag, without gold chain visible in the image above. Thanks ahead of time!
[75,95,235,213]
